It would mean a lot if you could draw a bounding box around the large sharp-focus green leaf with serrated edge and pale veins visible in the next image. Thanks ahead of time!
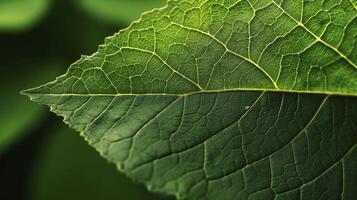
[24,0,357,200]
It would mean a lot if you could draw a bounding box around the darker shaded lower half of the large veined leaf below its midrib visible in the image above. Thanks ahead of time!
[25,91,357,199]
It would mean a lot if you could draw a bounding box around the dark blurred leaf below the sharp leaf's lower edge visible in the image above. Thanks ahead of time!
[29,127,171,200]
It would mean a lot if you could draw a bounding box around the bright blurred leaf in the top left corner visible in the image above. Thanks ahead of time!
[0,0,50,31]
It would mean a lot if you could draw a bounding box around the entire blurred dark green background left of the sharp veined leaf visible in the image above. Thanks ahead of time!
[0,0,172,200]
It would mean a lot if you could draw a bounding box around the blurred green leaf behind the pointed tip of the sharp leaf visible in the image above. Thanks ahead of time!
[0,63,60,153]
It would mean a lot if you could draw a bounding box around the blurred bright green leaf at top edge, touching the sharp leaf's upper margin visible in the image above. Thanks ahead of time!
[77,0,165,24]
